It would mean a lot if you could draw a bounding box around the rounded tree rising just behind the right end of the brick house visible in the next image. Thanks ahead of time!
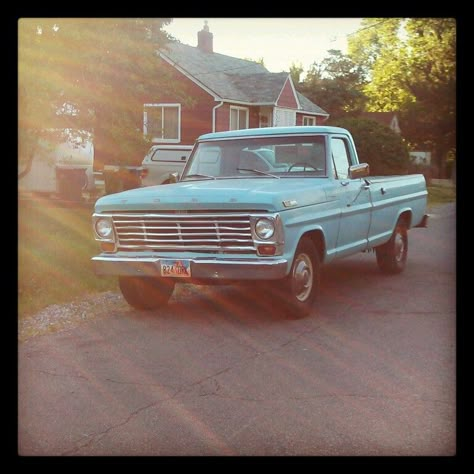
[298,50,365,118]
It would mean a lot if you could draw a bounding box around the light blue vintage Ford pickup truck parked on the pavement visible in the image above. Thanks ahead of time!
[92,126,428,317]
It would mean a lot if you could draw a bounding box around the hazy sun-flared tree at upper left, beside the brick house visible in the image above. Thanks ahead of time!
[18,18,182,176]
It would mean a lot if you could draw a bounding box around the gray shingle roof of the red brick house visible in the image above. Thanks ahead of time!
[160,42,327,115]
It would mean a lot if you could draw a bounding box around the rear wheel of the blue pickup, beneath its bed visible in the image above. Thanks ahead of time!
[375,219,408,274]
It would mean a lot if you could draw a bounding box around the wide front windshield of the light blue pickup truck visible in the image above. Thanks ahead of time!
[181,135,326,180]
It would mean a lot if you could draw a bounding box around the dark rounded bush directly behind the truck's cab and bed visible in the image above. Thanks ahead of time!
[331,117,410,176]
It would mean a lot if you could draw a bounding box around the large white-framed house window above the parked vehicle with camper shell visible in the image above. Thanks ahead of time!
[143,104,181,142]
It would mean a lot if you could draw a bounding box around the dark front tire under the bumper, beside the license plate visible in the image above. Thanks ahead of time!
[119,277,175,310]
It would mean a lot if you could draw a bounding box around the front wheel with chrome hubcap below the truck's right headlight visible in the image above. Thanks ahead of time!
[284,237,321,318]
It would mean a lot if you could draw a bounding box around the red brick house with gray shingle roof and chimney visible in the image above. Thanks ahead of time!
[143,22,329,144]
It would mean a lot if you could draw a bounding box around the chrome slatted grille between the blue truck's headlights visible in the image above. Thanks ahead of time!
[113,213,255,253]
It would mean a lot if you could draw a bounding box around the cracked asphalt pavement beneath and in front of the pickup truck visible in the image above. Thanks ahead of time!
[18,204,456,456]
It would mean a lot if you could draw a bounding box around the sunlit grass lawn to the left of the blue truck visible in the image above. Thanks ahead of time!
[18,200,118,318]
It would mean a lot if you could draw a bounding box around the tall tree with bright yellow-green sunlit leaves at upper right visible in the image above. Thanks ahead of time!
[349,18,456,178]
